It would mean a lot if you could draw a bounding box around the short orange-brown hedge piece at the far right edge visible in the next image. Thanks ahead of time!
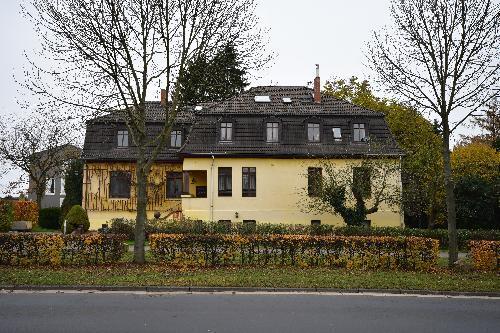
[469,241,500,271]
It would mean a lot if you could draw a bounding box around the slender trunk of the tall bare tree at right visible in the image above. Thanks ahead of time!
[443,119,458,267]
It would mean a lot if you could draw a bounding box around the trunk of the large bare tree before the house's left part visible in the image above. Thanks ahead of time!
[134,161,148,264]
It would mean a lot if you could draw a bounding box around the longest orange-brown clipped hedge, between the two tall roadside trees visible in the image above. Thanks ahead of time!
[149,234,439,271]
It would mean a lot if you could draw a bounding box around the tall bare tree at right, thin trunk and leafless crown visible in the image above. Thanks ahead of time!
[368,0,500,266]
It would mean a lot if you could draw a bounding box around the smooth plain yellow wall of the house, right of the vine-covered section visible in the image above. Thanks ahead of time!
[182,157,403,226]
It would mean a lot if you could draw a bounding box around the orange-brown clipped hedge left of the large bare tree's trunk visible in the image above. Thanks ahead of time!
[0,233,126,266]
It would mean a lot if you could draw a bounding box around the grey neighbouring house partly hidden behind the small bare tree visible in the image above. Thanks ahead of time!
[28,144,82,208]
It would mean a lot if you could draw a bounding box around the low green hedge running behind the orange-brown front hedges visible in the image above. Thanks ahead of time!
[108,219,500,251]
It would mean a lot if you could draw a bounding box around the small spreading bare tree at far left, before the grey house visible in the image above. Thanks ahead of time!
[0,114,79,208]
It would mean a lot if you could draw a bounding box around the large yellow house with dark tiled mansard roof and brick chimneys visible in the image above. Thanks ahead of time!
[82,67,403,228]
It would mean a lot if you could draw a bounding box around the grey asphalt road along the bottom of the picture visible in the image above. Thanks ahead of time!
[0,292,500,333]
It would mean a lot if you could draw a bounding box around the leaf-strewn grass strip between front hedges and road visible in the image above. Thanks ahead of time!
[0,254,500,292]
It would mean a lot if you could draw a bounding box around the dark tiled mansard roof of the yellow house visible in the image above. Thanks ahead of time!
[83,86,402,161]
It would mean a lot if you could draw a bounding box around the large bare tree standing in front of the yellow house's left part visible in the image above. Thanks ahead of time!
[25,0,268,263]
